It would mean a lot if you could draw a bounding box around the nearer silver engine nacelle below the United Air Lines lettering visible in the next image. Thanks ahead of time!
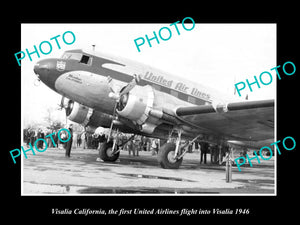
[117,85,159,134]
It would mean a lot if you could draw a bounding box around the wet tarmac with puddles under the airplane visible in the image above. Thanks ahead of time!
[21,148,276,196]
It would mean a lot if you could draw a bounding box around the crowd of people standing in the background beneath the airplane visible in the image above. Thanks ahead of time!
[23,125,229,164]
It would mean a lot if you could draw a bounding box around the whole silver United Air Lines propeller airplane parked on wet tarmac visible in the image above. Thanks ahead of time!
[33,49,274,169]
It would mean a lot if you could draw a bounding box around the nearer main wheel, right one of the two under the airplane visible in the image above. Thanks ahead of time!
[158,143,183,169]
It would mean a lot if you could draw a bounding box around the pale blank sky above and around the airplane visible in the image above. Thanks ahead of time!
[21,23,277,126]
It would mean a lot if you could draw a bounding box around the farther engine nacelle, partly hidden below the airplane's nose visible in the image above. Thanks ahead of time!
[66,100,112,127]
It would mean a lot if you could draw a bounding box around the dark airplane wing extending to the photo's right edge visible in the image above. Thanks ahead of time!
[176,100,274,141]
